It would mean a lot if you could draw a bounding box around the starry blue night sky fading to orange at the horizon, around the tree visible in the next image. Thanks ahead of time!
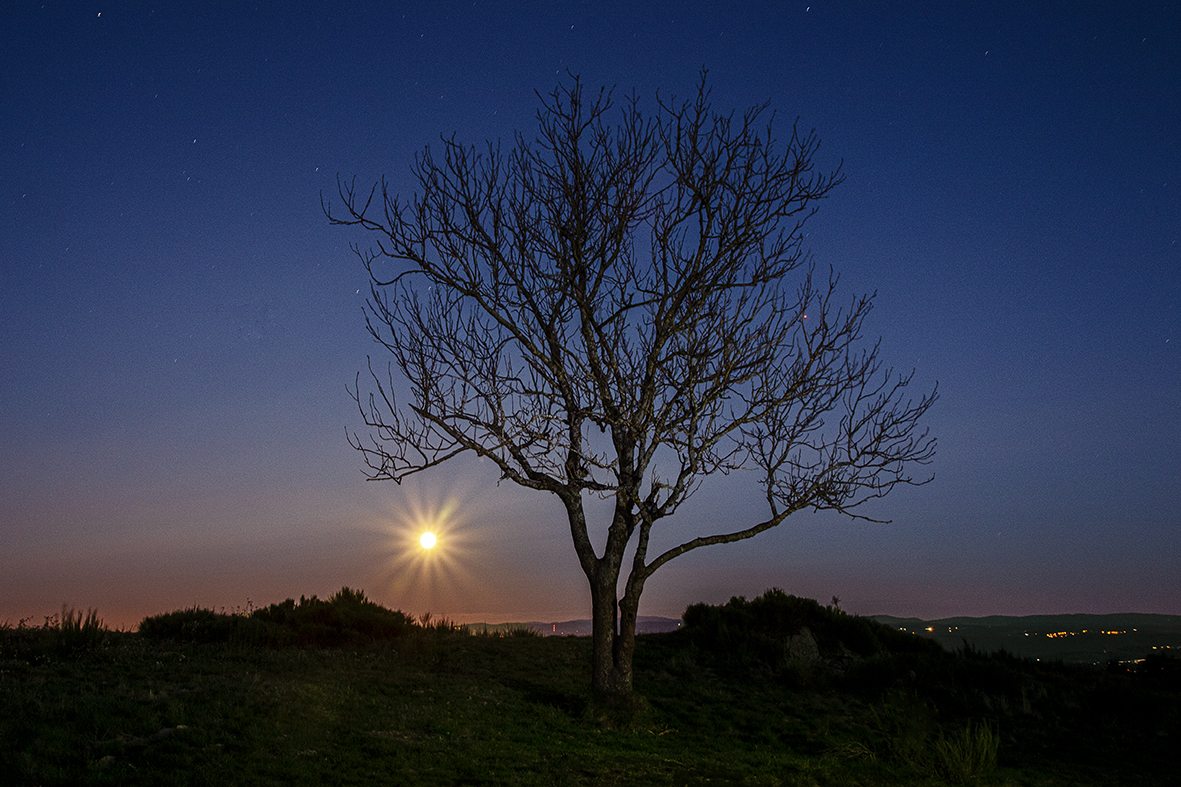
[0,0,1181,626]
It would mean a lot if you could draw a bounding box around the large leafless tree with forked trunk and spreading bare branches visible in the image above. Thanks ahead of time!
[325,73,935,697]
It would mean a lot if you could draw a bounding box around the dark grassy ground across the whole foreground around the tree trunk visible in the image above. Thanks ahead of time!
[0,586,1179,787]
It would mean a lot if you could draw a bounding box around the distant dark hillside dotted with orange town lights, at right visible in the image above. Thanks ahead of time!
[870,612,1181,664]
